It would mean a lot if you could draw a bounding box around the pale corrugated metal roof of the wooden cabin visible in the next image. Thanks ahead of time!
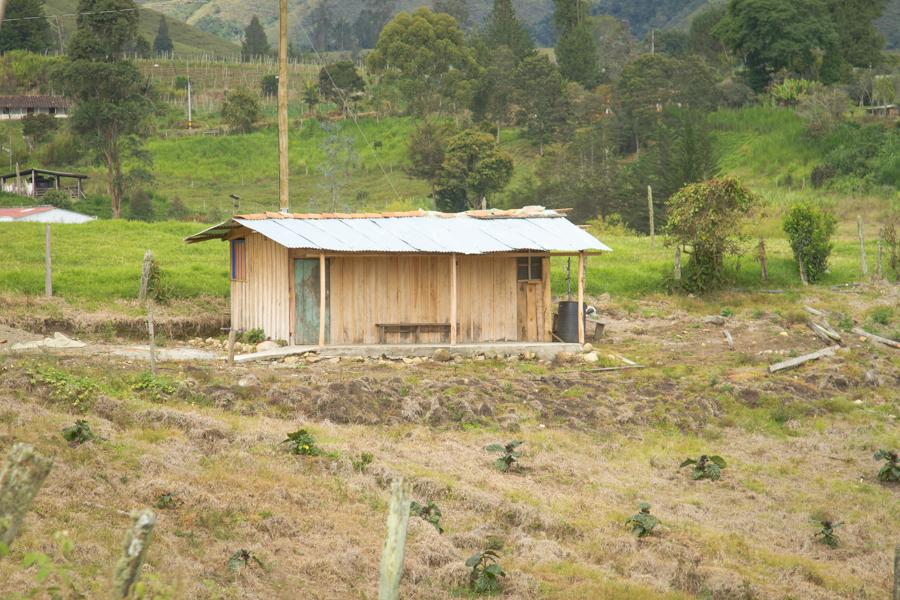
[186,207,610,254]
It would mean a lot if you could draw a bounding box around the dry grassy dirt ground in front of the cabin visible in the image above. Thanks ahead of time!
[0,288,900,600]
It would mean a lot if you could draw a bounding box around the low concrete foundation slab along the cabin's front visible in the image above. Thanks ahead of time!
[234,342,581,363]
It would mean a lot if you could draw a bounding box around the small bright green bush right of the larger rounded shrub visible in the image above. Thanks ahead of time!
[782,204,837,283]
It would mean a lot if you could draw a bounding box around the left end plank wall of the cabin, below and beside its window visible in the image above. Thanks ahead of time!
[231,232,291,341]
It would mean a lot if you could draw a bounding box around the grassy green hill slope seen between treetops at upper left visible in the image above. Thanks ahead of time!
[46,0,240,56]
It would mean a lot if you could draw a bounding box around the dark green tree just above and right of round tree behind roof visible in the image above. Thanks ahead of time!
[515,54,570,154]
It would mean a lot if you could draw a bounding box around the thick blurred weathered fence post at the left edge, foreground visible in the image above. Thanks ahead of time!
[0,443,53,548]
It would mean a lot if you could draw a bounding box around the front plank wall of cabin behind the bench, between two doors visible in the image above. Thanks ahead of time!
[330,256,517,344]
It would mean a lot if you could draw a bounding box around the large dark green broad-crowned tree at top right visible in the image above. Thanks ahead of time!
[716,0,843,91]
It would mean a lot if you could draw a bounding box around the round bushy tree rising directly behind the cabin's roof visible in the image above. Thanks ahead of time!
[437,130,513,212]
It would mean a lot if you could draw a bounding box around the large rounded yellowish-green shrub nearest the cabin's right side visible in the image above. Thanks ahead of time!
[666,178,759,292]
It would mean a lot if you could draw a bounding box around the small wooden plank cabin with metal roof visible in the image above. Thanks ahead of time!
[185,207,609,346]
